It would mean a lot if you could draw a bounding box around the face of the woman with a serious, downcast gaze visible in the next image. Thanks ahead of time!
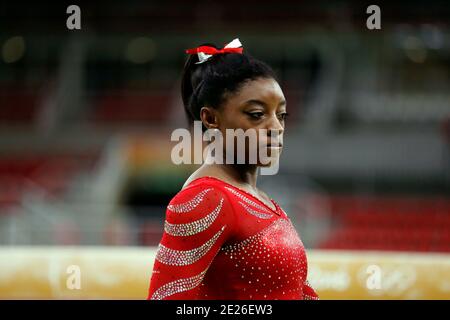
[209,78,287,166]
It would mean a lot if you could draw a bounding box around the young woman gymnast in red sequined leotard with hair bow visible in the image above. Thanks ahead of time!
[148,39,318,300]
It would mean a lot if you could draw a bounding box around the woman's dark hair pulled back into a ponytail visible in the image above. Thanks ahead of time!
[181,43,276,130]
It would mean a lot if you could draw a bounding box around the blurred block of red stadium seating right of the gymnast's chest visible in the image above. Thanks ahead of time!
[319,196,450,252]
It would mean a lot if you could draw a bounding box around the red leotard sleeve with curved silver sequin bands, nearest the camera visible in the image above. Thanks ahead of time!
[148,184,234,300]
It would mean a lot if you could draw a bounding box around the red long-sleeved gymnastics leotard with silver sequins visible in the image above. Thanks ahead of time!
[148,177,318,300]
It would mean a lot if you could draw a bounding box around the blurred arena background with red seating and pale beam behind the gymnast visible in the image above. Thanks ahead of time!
[0,0,450,299]
